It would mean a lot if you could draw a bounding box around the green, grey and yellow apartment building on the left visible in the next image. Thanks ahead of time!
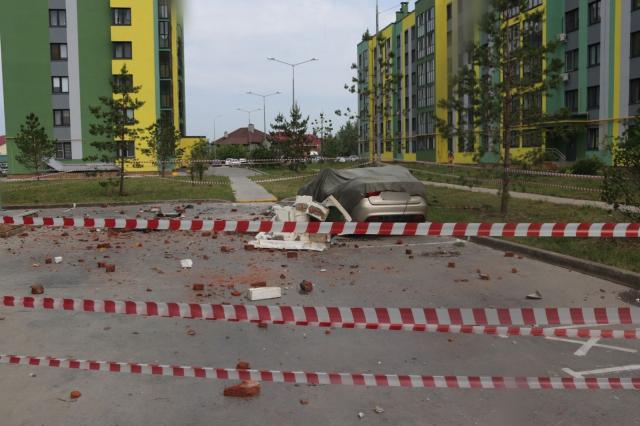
[0,0,186,174]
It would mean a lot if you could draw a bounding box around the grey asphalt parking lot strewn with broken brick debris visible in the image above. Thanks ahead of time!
[0,204,640,425]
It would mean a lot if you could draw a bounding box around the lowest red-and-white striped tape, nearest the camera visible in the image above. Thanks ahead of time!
[0,355,640,390]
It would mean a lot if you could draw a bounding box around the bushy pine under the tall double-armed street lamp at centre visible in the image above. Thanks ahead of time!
[268,104,309,170]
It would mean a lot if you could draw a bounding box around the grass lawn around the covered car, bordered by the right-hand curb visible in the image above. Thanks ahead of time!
[262,178,640,272]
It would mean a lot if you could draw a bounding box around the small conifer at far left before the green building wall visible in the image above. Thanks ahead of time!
[15,113,56,179]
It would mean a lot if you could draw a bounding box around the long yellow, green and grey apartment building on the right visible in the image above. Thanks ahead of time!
[358,0,640,163]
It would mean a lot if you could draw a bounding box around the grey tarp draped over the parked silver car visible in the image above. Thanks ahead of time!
[298,166,426,212]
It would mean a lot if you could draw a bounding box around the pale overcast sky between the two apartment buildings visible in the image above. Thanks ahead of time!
[0,0,400,138]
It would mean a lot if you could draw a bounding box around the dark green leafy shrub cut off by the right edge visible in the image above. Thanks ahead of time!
[602,116,640,220]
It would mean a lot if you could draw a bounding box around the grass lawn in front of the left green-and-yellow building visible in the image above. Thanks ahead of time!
[0,178,234,206]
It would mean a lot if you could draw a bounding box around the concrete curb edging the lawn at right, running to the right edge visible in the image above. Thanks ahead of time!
[471,237,640,290]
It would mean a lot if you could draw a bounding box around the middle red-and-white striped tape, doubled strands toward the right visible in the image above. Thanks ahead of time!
[5,296,640,332]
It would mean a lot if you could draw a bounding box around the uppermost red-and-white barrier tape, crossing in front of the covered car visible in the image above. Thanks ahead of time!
[0,216,640,238]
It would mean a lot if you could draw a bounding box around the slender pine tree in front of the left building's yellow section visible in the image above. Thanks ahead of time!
[89,65,144,196]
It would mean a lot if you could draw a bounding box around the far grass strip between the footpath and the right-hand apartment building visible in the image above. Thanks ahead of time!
[403,163,602,201]
